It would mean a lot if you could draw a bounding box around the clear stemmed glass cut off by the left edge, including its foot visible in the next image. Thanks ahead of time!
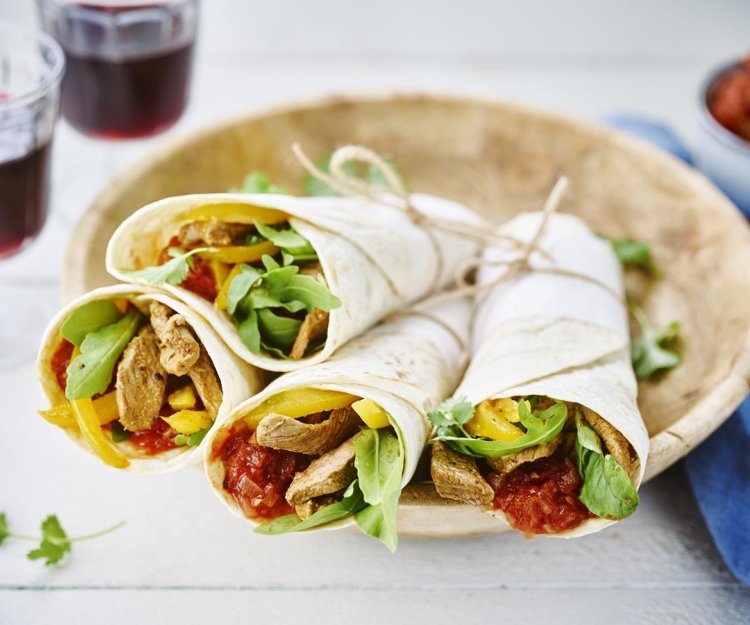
[0,23,65,368]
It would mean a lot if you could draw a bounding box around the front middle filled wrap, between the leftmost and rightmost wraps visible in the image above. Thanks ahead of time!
[206,300,471,550]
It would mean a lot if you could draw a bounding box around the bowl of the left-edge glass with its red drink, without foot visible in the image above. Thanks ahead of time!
[0,24,65,259]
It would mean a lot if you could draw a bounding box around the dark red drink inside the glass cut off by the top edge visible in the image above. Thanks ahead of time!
[62,44,193,139]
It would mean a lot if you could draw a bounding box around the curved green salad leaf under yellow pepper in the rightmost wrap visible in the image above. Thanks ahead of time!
[427,398,568,458]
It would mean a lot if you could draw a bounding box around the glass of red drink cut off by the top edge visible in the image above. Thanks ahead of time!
[37,0,199,139]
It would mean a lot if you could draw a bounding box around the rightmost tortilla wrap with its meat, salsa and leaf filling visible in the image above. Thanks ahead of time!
[430,213,648,537]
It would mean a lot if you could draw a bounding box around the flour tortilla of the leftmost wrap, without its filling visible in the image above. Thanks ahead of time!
[37,285,265,474]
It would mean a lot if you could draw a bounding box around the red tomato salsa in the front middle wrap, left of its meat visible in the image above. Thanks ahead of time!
[214,423,310,520]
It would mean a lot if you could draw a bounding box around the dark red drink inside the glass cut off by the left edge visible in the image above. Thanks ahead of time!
[0,142,51,258]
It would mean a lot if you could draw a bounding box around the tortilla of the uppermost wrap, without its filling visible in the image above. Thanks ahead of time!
[106,194,478,371]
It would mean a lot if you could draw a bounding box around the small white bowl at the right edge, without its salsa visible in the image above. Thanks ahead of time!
[696,61,750,217]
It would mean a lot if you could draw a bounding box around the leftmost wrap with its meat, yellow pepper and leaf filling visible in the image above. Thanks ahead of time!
[37,285,264,473]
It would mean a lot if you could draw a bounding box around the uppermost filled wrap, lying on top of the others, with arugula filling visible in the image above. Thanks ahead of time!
[107,193,477,371]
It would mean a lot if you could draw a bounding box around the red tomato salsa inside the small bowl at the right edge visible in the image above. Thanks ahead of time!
[708,57,750,141]
